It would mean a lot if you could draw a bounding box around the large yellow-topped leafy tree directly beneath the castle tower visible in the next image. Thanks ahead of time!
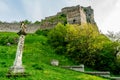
[66,24,101,65]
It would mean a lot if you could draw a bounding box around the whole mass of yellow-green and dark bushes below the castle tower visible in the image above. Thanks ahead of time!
[48,23,120,74]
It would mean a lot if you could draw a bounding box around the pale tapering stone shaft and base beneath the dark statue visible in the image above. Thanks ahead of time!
[10,35,25,73]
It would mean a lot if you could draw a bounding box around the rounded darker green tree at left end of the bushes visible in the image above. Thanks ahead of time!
[48,23,66,54]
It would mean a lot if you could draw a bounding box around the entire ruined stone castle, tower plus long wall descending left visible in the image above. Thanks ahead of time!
[0,5,96,33]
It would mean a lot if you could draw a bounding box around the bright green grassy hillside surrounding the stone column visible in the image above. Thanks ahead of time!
[0,33,107,80]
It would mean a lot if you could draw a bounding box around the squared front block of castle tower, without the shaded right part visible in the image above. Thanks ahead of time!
[62,5,86,24]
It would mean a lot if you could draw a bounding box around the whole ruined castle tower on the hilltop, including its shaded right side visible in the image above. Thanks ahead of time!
[62,5,95,24]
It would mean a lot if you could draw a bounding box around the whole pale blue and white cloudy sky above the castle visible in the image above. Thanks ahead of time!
[0,0,120,34]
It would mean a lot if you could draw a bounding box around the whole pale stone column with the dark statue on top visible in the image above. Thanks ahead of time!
[10,22,26,73]
